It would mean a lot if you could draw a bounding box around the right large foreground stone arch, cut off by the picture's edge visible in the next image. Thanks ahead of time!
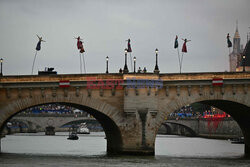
[157,92,250,156]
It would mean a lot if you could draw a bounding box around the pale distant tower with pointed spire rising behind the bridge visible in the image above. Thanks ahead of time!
[229,21,242,72]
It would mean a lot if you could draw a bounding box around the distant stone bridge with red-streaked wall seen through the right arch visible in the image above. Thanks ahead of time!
[163,118,242,139]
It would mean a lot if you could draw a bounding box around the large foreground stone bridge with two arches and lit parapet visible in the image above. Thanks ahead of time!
[0,72,250,155]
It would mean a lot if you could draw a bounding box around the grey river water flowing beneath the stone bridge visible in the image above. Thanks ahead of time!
[0,132,250,167]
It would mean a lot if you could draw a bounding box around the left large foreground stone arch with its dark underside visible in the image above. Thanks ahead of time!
[0,95,123,153]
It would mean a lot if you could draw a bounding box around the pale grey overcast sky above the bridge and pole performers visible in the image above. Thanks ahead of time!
[0,0,250,75]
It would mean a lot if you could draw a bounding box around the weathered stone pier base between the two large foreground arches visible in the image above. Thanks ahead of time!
[116,109,156,155]
